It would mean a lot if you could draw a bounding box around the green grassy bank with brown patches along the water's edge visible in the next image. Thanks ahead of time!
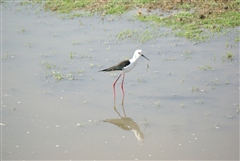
[21,0,240,41]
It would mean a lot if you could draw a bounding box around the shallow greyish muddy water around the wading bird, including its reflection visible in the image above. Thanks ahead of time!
[1,2,239,160]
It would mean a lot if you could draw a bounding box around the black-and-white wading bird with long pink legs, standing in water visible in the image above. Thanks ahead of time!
[99,49,149,98]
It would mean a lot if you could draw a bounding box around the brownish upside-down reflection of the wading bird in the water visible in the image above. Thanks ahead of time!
[103,96,144,141]
